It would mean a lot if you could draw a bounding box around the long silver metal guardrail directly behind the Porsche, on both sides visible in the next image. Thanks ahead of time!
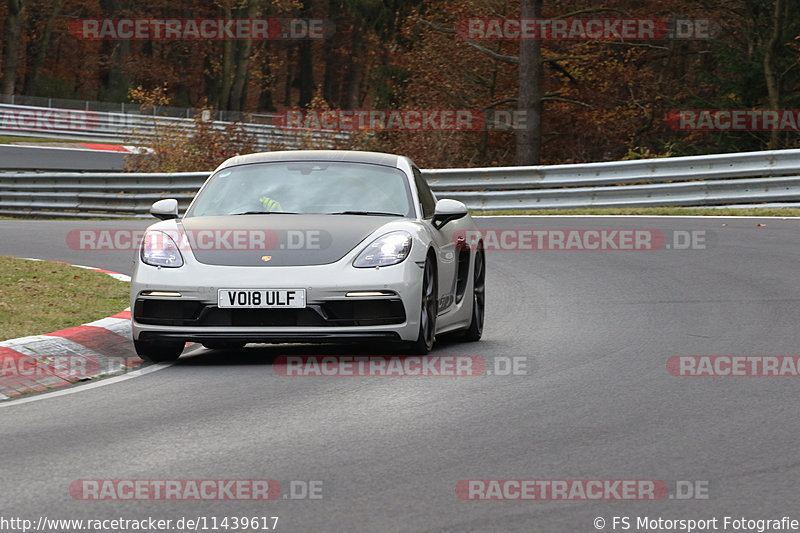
[0,150,800,217]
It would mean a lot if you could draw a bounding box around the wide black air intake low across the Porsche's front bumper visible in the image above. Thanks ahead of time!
[133,298,406,327]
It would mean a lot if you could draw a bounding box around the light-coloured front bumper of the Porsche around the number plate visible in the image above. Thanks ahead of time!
[131,260,422,342]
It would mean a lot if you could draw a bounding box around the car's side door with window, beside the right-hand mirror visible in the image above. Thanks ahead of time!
[412,167,458,315]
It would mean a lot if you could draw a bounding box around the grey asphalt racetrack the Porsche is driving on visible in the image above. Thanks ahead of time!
[0,217,800,532]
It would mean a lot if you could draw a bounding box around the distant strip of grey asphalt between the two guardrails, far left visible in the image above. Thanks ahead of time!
[0,145,125,172]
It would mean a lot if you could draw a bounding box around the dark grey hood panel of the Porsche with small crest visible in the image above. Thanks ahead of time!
[179,214,398,267]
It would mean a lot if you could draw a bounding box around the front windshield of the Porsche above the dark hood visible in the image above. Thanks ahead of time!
[186,161,414,217]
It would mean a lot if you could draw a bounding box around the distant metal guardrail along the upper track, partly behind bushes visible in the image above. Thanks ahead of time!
[0,104,351,151]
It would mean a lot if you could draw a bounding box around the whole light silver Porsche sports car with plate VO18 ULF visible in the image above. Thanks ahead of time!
[131,150,486,362]
